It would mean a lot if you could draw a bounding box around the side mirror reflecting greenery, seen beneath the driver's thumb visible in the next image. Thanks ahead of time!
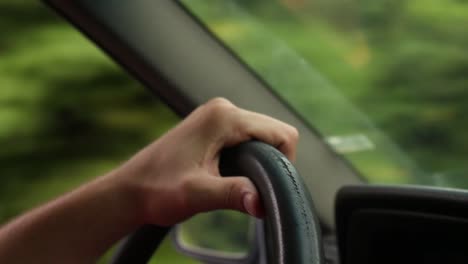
[174,210,255,260]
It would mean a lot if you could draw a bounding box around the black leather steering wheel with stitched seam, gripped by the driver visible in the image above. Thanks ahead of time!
[111,141,325,264]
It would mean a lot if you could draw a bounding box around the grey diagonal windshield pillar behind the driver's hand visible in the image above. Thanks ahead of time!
[46,0,364,229]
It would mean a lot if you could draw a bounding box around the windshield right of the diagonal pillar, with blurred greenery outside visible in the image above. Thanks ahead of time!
[182,0,468,188]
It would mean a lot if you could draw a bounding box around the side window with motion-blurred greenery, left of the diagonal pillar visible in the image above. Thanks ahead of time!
[0,0,197,264]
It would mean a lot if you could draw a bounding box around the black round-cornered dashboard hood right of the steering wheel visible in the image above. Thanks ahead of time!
[336,186,468,264]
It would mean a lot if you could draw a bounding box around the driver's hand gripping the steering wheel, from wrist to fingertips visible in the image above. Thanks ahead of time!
[111,98,298,225]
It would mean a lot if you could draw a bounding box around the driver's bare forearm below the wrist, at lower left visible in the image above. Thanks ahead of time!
[0,172,141,263]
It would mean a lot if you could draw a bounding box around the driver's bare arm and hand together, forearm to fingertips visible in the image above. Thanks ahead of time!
[0,98,298,263]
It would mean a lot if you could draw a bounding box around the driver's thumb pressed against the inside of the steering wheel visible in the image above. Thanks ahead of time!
[191,176,264,218]
